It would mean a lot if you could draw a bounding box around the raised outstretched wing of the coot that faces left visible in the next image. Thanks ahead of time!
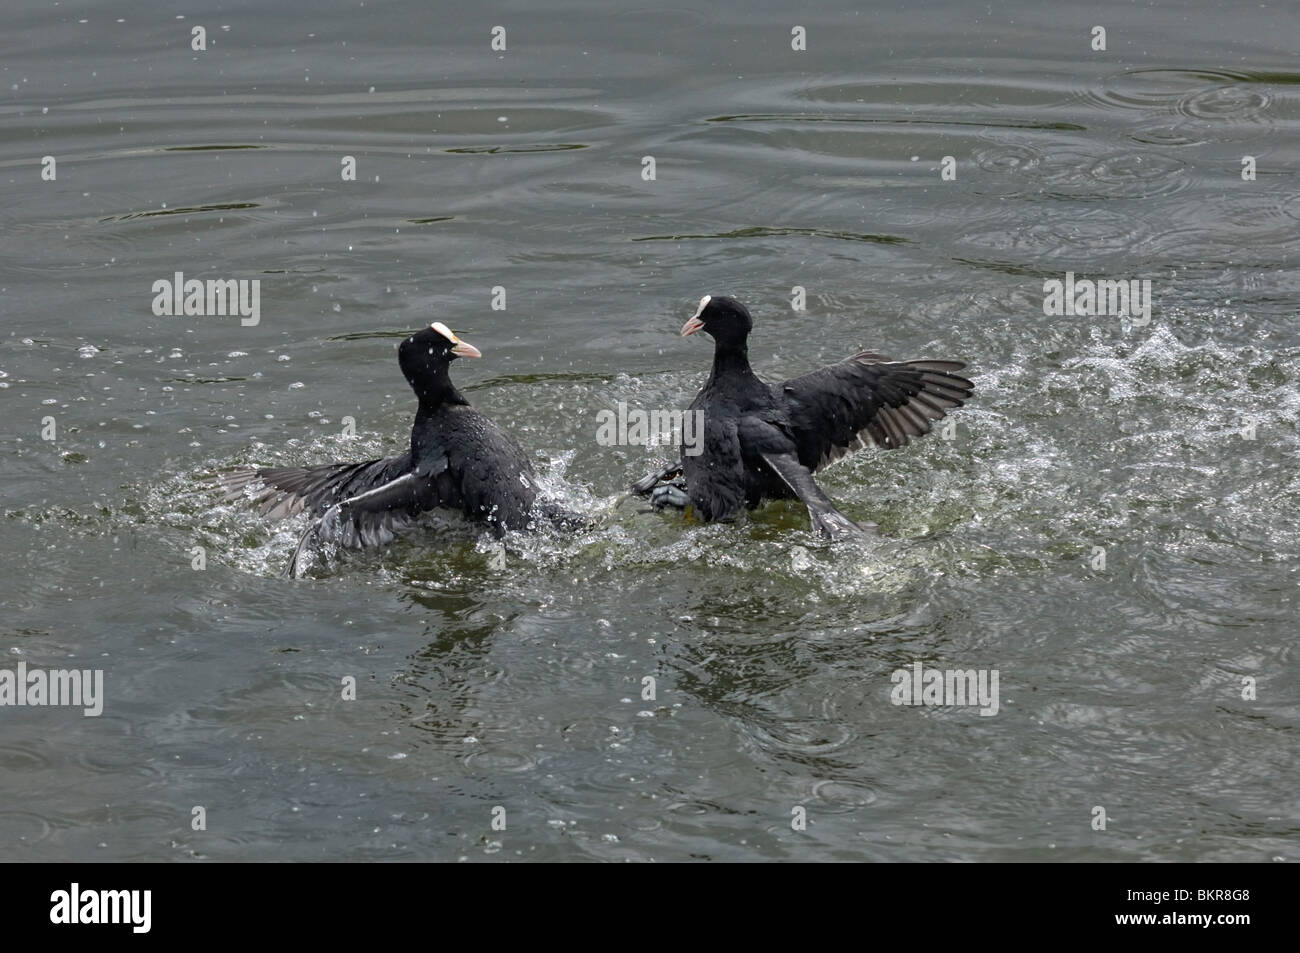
[774,351,975,472]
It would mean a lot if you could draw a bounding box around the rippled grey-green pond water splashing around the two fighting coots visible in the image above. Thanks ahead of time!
[0,0,1300,861]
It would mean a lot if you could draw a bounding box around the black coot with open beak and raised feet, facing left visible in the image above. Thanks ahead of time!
[632,295,974,538]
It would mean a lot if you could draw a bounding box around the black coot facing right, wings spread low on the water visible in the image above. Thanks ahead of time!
[221,324,581,576]
